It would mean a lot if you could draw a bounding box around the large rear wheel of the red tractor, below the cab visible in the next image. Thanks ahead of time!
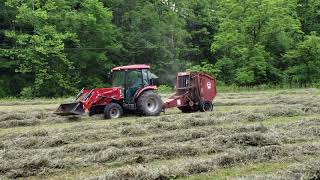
[137,91,163,116]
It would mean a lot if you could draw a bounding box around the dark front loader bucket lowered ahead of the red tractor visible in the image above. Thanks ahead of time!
[54,102,84,116]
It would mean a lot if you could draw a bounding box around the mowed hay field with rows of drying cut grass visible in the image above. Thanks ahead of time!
[0,89,320,179]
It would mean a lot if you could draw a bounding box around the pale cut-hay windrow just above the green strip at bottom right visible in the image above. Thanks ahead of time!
[91,144,320,179]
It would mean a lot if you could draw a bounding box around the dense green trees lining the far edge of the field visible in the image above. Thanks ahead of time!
[0,0,320,97]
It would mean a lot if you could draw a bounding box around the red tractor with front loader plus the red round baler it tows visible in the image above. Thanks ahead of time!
[55,65,216,119]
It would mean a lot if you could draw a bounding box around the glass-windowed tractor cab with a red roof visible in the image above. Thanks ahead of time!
[112,65,157,104]
